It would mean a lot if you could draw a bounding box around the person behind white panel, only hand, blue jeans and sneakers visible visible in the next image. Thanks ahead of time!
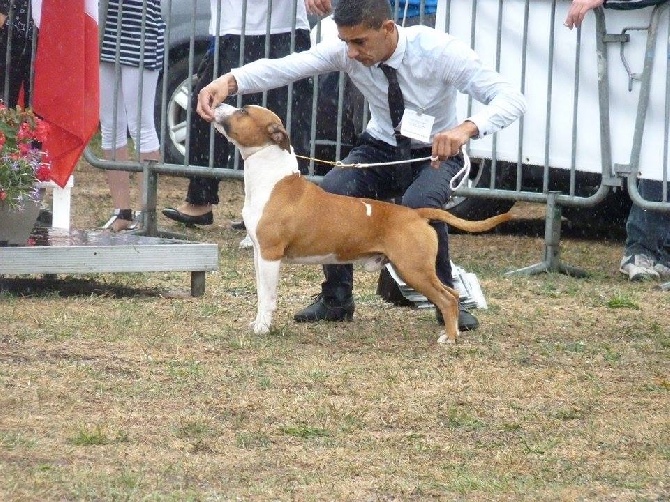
[565,0,670,280]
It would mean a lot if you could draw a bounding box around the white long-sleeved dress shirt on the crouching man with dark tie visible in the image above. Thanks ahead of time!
[232,26,526,147]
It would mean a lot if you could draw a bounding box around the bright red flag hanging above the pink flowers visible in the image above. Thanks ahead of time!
[33,0,100,187]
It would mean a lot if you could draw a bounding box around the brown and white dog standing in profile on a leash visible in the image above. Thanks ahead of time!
[215,104,510,343]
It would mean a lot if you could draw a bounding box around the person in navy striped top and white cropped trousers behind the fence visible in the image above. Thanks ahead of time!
[100,0,165,232]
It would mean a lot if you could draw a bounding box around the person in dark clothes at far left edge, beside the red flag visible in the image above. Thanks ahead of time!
[0,0,36,108]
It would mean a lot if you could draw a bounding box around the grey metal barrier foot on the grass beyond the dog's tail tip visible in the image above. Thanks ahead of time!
[505,192,588,277]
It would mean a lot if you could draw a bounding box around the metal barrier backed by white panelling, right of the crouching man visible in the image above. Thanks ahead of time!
[438,0,670,274]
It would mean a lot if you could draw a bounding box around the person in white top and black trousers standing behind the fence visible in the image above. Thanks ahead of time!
[163,0,312,225]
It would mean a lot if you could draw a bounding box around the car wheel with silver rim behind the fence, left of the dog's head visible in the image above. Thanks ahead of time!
[155,56,200,164]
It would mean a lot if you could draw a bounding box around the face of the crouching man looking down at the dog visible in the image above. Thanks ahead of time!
[337,20,398,66]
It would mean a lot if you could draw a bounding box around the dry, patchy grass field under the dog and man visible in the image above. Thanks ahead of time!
[0,164,670,501]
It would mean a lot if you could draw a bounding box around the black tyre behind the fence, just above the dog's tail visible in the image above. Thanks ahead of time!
[445,159,515,220]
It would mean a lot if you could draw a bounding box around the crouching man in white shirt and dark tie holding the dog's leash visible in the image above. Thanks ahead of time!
[197,0,526,331]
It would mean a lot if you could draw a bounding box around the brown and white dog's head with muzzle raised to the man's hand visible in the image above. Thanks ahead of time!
[214,103,291,157]
